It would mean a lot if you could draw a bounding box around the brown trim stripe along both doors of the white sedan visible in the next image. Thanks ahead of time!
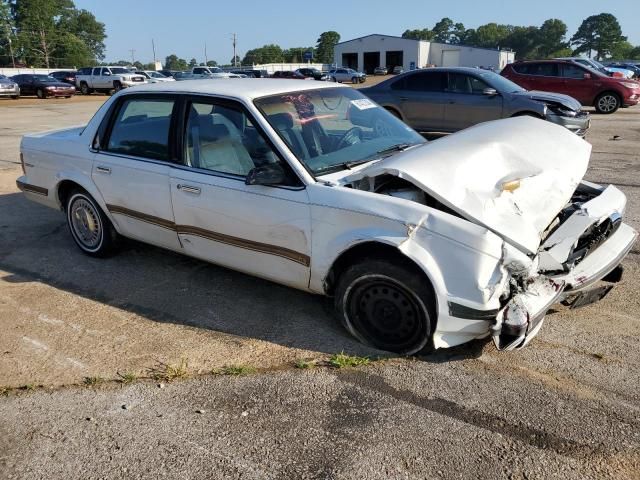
[107,205,311,267]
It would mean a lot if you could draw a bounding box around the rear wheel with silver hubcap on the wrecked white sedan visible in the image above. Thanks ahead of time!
[65,189,118,257]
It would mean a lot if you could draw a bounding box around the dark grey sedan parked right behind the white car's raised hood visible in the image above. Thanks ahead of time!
[360,67,590,136]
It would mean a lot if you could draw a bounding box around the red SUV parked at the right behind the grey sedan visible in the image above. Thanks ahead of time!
[500,60,640,113]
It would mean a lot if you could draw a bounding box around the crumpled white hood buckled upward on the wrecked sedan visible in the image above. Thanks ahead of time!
[342,117,591,253]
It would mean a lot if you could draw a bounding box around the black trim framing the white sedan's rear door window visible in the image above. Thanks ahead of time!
[99,93,183,164]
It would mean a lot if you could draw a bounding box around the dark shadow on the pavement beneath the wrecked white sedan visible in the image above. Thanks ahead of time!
[0,193,484,362]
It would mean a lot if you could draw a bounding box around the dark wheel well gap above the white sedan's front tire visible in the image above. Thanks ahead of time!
[325,242,435,298]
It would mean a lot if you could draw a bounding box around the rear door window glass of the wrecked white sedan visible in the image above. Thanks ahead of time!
[106,97,175,161]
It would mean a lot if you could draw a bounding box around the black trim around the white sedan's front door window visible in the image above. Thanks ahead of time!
[175,94,305,190]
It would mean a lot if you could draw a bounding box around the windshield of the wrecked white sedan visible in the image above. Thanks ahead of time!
[255,87,426,175]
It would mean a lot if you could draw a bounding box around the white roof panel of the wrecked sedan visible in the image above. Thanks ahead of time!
[120,78,340,101]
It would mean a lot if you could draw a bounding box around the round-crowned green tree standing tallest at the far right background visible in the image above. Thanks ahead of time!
[571,13,627,60]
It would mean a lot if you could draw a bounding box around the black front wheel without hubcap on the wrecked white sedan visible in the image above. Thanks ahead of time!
[335,259,435,355]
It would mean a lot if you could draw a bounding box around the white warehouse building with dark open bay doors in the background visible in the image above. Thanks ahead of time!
[333,34,515,74]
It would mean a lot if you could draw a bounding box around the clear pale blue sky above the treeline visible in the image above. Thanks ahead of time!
[75,0,640,63]
